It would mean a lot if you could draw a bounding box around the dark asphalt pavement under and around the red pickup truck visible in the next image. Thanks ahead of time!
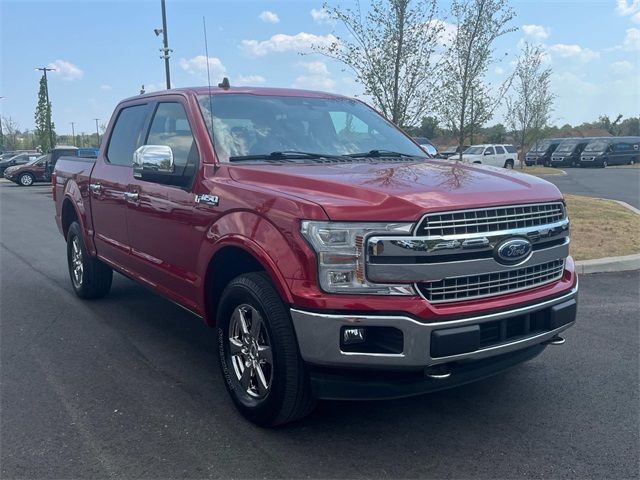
[0,181,640,478]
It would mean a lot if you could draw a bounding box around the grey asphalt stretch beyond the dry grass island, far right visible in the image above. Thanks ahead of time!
[544,167,640,208]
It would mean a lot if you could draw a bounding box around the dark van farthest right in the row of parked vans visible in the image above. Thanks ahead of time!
[580,137,640,168]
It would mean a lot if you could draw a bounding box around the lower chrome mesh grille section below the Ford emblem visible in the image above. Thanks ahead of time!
[417,260,564,303]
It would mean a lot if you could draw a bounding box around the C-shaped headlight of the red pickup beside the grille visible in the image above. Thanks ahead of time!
[300,221,416,295]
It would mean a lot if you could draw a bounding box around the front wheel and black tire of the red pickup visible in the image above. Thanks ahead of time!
[217,272,315,427]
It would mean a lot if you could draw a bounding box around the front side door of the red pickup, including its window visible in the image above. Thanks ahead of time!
[127,98,211,311]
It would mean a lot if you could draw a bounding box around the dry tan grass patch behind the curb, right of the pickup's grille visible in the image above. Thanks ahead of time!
[565,195,640,260]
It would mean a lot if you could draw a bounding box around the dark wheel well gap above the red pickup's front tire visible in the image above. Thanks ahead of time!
[204,247,264,325]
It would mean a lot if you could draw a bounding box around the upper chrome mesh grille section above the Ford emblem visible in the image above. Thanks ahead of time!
[416,202,566,237]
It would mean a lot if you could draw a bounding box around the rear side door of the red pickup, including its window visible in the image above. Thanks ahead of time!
[89,103,149,268]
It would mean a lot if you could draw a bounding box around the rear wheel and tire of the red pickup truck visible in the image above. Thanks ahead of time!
[67,222,113,299]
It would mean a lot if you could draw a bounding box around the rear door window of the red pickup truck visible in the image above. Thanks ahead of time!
[106,104,147,166]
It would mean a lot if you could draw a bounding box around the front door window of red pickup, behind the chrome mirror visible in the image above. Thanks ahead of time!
[145,102,198,174]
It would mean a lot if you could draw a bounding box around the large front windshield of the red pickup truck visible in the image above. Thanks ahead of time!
[198,94,426,162]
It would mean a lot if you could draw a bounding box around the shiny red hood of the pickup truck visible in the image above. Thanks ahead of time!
[229,160,562,221]
